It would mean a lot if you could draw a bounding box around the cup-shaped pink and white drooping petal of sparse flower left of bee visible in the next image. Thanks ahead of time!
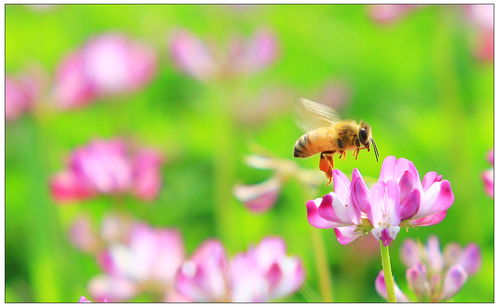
[234,177,281,213]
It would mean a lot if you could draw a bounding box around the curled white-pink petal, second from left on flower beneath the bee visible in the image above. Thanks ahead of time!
[319,192,360,227]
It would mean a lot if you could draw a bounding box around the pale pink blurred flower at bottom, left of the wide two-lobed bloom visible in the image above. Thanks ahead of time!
[89,223,184,301]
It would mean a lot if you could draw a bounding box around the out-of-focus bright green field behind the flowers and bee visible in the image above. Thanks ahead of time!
[5,5,494,302]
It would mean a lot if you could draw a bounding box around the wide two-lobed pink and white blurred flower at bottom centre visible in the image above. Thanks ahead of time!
[175,237,305,302]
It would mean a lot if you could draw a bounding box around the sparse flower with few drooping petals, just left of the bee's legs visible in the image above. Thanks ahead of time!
[234,155,322,213]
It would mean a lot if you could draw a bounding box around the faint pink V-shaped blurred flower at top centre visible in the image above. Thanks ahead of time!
[169,30,278,81]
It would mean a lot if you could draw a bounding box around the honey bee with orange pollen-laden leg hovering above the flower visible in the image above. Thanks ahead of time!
[293,98,379,184]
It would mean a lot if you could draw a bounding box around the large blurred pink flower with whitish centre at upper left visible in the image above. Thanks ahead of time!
[53,33,156,108]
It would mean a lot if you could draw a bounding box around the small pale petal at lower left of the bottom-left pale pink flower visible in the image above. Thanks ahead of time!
[88,275,137,302]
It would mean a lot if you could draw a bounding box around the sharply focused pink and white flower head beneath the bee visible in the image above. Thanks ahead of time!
[306,156,454,246]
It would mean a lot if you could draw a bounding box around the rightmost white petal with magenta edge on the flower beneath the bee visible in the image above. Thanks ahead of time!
[413,180,454,219]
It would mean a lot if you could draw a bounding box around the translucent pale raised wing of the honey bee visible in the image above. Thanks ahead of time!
[297,98,340,132]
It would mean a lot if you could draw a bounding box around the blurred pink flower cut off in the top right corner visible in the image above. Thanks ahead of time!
[464,4,494,61]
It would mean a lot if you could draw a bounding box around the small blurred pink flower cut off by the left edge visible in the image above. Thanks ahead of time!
[5,71,41,121]
